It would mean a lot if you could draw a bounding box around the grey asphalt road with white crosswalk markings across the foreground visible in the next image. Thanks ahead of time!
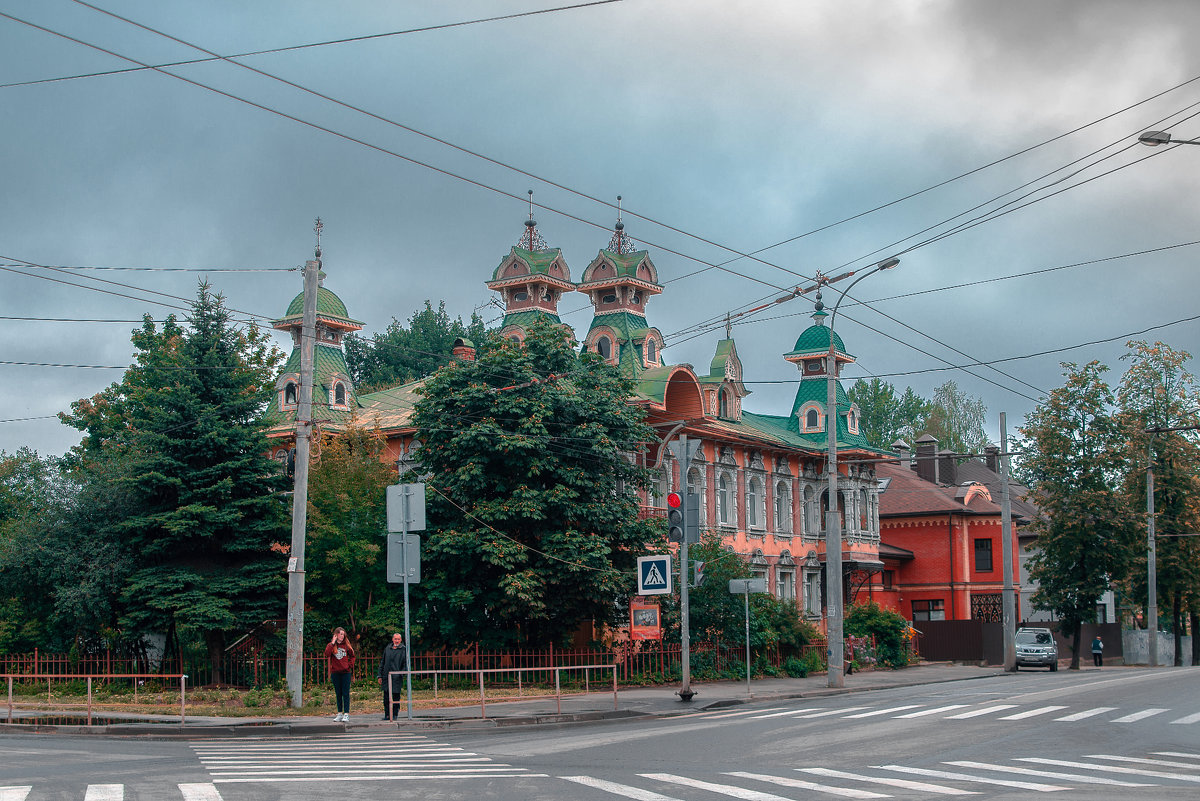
[0,669,1200,801]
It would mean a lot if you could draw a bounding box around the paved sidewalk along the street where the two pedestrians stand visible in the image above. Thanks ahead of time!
[0,664,1004,737]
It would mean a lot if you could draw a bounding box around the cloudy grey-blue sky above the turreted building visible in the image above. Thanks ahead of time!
[0,0,1200,456]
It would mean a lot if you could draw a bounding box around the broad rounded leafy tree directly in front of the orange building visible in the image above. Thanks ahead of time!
[413,316,661,648]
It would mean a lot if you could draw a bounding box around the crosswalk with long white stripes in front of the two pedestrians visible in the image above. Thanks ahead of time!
[190,734,544,781]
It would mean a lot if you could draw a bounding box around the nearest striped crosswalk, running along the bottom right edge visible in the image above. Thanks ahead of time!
[558,751,1200,801]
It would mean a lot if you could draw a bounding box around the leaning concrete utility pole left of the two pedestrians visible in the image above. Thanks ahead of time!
[286,236,322,707]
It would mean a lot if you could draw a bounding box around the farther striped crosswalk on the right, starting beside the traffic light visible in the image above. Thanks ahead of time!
[685,701,1200,725]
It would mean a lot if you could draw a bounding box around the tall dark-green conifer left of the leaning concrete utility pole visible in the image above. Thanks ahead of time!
[64,283,287,682]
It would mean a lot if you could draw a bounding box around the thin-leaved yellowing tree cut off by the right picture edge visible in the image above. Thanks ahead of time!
[1117,342,1200,666]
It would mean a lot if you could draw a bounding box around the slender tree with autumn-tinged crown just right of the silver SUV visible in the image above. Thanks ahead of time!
[1020,361,1136,670]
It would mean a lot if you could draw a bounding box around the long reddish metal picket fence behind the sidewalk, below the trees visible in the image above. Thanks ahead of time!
[0,640,826,687]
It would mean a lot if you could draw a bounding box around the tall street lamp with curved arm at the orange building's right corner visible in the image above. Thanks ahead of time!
[826,257,900,687]
